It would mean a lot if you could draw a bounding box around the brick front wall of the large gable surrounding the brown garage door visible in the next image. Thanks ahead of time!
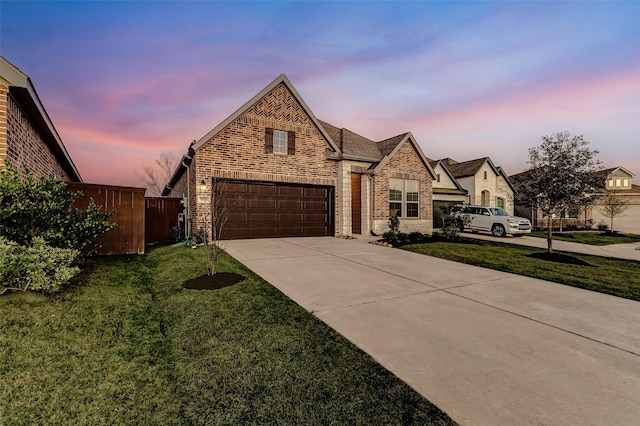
[189,84,340,235]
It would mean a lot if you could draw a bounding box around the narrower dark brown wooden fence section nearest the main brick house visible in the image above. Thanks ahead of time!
[144,197,184,244]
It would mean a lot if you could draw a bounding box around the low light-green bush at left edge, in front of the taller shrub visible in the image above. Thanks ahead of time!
[0,237,80,294]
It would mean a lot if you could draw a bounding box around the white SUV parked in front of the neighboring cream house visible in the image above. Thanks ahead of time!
[451,205,531,237]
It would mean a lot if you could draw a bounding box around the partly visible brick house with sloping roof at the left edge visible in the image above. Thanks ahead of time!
[0,56,82,182]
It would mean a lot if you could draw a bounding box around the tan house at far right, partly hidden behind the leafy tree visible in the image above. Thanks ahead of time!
[510,167,640,233]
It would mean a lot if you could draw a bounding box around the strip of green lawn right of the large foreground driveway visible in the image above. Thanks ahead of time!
[402,240,640,301]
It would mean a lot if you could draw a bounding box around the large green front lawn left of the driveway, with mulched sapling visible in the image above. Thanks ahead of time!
[0,247,453,425]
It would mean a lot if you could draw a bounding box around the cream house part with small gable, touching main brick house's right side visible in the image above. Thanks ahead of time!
[429,160,469,228]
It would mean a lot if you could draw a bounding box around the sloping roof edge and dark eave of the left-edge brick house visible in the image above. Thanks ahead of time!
[0,56,82,182]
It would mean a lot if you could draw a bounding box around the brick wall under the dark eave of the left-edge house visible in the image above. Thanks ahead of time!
[0,90,70,181]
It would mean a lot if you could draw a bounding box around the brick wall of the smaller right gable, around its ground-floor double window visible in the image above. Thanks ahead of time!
[372,141,433,234]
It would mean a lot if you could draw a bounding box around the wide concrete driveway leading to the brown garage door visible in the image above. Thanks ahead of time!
[224,237,640,425]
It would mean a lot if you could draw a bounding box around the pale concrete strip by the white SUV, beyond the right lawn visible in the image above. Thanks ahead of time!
[462,232,640,261]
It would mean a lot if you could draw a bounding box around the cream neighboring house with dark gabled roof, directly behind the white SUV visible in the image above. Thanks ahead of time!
[438,157,516,214]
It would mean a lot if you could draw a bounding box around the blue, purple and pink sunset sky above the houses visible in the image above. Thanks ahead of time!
[0,0,640,186]
